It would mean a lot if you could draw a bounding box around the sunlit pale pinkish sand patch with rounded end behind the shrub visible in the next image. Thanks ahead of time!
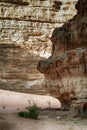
[0,90,61,113]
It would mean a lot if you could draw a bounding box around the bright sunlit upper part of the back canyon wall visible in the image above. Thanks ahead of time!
[0,0,77,57]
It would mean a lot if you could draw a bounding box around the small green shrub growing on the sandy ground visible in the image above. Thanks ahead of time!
[18,105,39,119]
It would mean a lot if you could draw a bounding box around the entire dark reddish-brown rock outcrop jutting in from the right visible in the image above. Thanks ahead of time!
[38,0,87,111]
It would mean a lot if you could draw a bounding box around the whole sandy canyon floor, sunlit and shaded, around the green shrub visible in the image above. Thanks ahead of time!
[0,90,87,130]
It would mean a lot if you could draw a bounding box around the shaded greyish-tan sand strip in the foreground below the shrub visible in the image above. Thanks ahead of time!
[0,114,87,130]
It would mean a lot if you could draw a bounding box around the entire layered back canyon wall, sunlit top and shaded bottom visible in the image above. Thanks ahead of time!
[0,0,77,94]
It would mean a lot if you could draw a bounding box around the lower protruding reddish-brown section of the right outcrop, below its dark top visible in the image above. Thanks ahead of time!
[38,48,87,102]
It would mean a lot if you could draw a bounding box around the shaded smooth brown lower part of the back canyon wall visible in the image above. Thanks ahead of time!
[0,44,46,94]
